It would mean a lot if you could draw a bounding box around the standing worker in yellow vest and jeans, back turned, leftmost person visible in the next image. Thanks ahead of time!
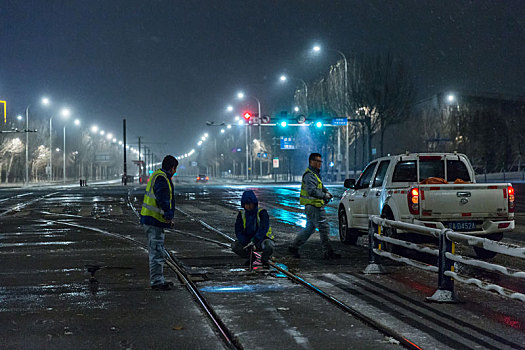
[140,155,179,290]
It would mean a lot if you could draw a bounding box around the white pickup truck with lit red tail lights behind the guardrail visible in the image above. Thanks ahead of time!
[338,153,514,258]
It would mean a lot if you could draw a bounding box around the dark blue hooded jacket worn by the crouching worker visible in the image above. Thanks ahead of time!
[235,191,270,246]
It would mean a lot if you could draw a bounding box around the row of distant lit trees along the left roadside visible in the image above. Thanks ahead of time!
[0,115,122,183]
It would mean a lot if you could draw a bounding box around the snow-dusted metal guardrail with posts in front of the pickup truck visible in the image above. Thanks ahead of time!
[363,215,525,303]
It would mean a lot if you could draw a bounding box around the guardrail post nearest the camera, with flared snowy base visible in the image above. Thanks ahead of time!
[426,229,458,303]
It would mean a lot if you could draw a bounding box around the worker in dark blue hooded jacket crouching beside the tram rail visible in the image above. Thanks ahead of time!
[232,191,275,266]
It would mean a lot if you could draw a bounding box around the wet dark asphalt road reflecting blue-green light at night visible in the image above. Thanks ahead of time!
[0,183,525,349]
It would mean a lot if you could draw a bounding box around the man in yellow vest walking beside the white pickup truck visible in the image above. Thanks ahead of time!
[288,153,341,259]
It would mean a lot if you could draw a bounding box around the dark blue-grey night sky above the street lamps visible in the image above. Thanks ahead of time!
[0,0,525,155]
